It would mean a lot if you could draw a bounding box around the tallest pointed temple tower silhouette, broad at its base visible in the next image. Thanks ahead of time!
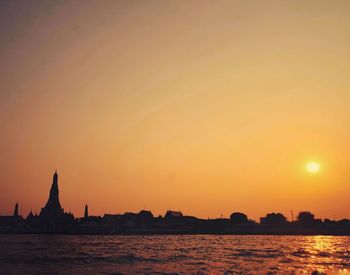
[40,171,64,220]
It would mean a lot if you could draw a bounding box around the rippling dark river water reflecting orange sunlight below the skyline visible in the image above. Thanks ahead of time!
[0,235,350,274]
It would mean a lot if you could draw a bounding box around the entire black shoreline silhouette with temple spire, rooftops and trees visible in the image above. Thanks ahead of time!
[0,171,350,235]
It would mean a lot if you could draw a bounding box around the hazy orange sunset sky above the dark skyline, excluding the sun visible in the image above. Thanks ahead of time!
[0,0,350,220]
